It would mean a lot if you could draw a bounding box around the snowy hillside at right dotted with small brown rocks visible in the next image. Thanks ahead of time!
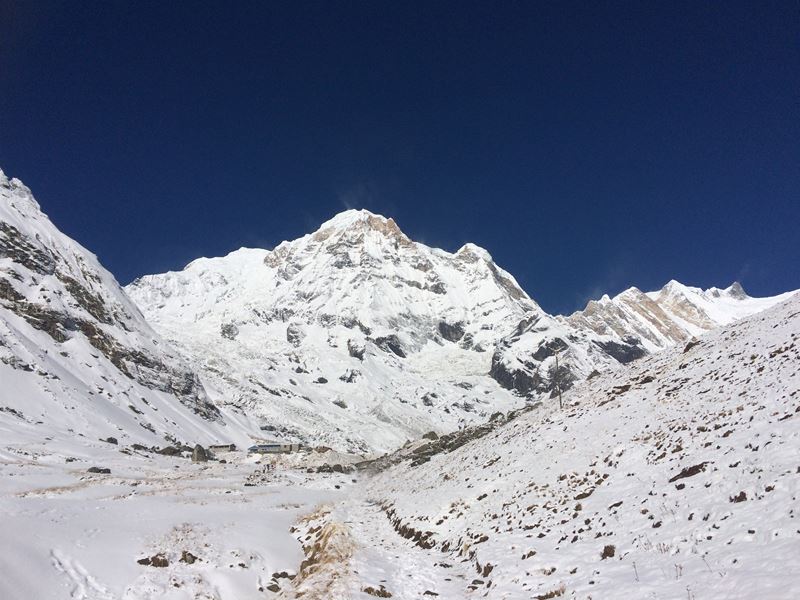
[310,292,800,600]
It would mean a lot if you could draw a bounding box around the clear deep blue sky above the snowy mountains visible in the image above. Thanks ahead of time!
[0,0,800,312]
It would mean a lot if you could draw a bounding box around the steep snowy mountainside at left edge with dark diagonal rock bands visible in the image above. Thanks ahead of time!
[0,171,258,444]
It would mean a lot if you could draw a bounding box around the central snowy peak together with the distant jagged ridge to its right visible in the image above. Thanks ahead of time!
[126,210,792,452]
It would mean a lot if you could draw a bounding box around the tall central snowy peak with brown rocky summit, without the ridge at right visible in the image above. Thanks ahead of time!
[127,210,543,452]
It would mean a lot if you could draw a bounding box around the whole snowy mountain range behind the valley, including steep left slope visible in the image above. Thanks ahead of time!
[0,172,791,455]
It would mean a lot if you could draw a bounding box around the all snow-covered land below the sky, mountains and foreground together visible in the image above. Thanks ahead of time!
[0,171,800,600]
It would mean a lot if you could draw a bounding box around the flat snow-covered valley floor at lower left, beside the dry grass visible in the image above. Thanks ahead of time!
[0,442,352,600]
